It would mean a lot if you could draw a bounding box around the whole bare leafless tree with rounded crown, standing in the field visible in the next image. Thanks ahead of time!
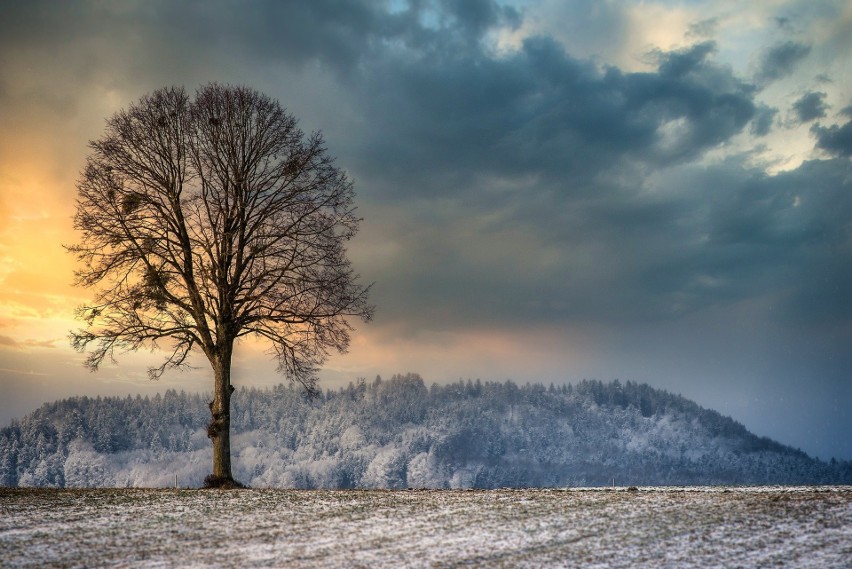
[69,84,373,486]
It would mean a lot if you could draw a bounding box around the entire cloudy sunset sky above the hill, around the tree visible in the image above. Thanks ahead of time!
[0,0,852,460]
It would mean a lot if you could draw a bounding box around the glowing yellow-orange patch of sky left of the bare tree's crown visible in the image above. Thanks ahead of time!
[0,77,143,358]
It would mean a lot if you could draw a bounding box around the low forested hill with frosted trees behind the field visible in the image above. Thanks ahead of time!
[0,374,852,488]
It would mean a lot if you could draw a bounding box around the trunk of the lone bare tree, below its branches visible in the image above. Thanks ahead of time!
[205,347,240,487]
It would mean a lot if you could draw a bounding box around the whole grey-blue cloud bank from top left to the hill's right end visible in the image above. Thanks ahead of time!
[0,0,852,458]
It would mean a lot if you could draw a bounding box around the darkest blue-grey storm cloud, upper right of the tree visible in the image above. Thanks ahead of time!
[356,38,756,193]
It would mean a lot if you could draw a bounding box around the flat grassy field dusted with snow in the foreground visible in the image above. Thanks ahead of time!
[0,487,852,569]
